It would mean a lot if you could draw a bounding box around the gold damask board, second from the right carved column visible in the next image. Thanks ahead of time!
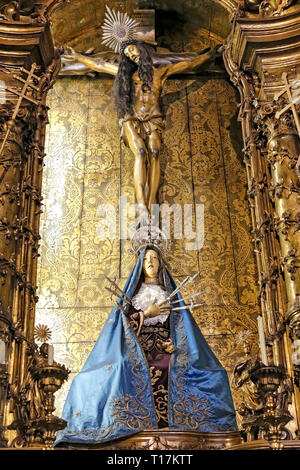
[188,80,236,312]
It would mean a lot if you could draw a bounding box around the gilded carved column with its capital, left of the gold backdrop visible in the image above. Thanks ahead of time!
[0,0,60,446]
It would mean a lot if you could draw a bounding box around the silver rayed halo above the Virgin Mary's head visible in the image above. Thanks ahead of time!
[129,225,169,256]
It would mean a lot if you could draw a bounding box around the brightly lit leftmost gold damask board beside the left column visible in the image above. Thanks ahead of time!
[39,80,89,307]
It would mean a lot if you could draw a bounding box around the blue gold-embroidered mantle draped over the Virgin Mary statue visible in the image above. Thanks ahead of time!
[55,252,237,445]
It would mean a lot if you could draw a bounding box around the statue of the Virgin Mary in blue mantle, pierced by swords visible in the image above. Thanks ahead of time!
[55,245,237,446]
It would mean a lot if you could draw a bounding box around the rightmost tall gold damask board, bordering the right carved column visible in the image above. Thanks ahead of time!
[215,80,257,310]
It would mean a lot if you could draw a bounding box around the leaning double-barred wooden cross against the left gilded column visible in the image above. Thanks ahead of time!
[0,64,40,156]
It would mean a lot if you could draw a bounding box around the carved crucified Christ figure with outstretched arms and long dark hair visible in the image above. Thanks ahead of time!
[64,40,216,213]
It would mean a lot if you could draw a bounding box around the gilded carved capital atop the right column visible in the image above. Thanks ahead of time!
[225,5,300,102]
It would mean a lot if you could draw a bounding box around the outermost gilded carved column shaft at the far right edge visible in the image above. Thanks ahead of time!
[267,116,300,334]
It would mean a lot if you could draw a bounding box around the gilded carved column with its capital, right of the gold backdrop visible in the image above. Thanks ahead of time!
[224,0,300,435]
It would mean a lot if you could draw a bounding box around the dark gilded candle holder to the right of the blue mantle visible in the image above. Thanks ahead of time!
[250,365,293,450]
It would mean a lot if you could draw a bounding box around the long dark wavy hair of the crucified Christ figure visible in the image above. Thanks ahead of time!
[113,40,153,118]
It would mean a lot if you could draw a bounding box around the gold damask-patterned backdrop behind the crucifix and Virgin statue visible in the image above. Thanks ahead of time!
[36,54,259,415]
